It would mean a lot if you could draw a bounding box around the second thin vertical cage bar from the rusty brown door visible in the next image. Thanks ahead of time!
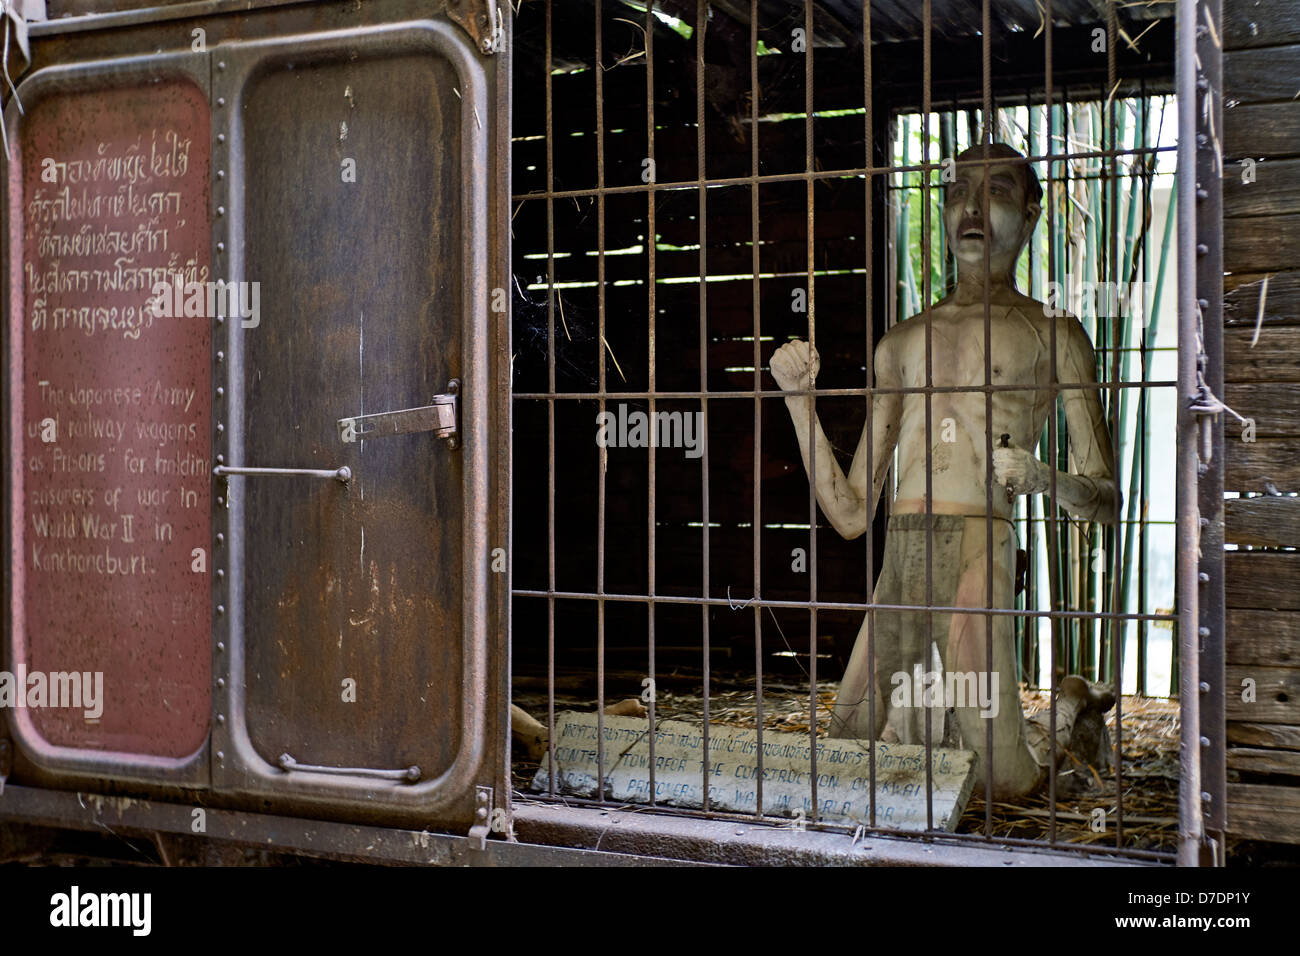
[595,0,608,803]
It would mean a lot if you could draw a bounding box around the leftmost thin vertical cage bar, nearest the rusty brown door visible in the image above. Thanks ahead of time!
[546,0,555,796]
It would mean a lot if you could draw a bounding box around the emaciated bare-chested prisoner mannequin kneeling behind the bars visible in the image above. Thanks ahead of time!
[771,143,1119,797]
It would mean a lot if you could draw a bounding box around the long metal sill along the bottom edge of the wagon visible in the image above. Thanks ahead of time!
[0,787,1149,868]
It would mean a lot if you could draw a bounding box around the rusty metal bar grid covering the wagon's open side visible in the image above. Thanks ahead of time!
[501,0,1196,858]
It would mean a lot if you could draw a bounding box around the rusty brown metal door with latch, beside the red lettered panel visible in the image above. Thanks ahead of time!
[212,7,504,826]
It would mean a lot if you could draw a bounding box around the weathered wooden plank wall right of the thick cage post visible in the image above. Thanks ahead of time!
[1223,0,1300,843]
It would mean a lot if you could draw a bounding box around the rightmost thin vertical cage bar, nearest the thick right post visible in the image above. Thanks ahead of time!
[1097,3,1125,847]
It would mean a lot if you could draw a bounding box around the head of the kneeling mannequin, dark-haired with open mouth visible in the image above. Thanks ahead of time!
[944,143,1043,277]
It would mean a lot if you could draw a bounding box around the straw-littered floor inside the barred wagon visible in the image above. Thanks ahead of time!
[514,682,1179,851]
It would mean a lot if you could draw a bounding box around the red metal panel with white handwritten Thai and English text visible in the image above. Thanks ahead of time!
[5,57,211,779]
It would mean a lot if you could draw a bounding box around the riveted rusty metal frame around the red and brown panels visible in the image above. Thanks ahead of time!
[0,0,511,837]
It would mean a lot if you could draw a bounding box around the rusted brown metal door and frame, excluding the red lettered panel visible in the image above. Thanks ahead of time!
[4,0,510,842]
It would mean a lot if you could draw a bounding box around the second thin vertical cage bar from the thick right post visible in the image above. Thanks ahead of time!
[1043,0,1070,844]
